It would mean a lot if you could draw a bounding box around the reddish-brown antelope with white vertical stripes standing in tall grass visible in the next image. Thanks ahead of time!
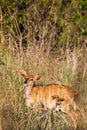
[19,69,78,128]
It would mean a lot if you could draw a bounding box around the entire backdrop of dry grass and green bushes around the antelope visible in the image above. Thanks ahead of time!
[0,0,87,130]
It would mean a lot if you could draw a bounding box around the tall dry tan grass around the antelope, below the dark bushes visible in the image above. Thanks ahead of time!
[0,44,87,130]
